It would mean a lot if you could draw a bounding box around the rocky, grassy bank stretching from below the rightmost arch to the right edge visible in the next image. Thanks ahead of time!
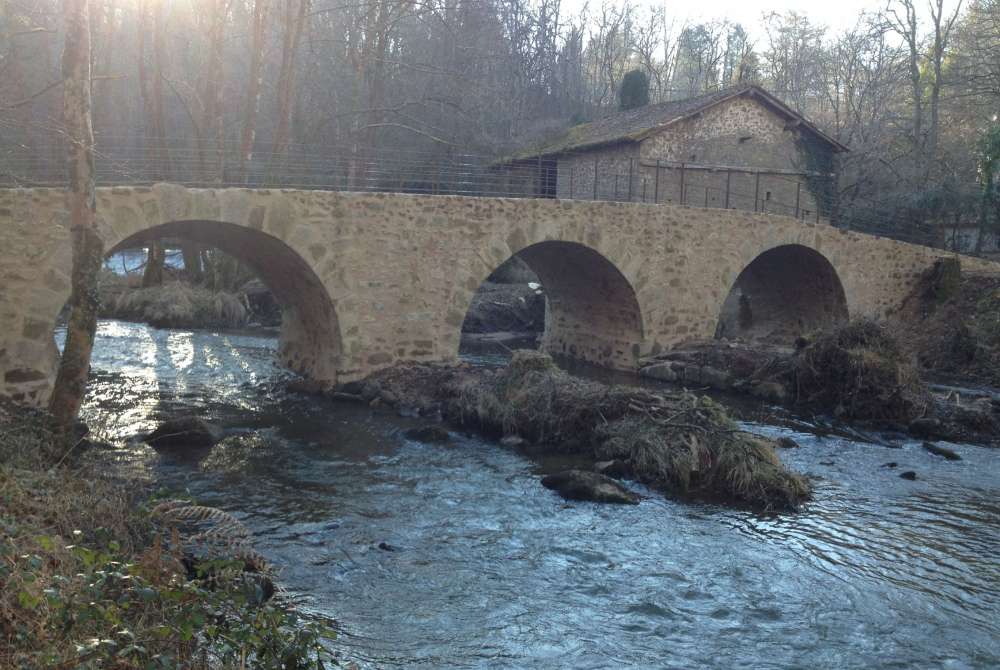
[639,321,1000,446]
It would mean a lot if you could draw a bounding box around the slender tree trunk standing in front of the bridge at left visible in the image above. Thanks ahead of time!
[49,0,104,433]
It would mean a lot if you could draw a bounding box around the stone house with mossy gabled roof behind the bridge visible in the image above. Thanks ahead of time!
[505,85,848,220]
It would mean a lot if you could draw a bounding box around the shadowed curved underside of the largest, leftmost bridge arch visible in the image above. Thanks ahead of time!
[108,221,343,383]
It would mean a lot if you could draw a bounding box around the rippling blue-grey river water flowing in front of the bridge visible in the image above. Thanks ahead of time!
[64,322,1000,669]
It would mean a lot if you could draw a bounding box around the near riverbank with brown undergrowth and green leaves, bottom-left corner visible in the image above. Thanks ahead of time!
[0,403,330,670]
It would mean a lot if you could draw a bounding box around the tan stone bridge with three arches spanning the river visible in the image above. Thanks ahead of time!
[0,184,1000,403]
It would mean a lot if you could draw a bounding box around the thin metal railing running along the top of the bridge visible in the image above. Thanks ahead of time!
[0,137,952,252]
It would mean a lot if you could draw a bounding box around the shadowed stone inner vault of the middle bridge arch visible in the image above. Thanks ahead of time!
[463,241,643,370]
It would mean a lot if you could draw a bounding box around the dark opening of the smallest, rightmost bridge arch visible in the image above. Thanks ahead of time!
[715,244,848,343]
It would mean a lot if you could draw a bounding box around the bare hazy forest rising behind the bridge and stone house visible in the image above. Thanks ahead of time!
[0,0,1000,249]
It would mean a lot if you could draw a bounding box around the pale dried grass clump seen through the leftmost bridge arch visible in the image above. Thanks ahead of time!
[105,281,248,328]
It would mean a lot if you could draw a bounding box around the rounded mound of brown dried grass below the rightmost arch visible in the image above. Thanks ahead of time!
[793,320,931,423]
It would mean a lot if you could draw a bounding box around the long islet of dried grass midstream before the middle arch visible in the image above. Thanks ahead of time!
[448,352,810,508]
